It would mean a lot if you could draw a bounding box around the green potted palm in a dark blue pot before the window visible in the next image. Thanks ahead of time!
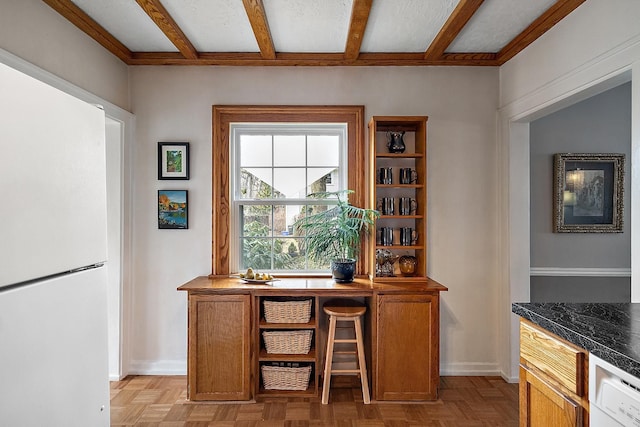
[294,190,380,283]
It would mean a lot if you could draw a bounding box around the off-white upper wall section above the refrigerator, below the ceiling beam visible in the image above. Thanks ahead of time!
[0,0,129,109]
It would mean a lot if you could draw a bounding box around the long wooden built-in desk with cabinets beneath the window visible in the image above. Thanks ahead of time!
[178,276,447,400]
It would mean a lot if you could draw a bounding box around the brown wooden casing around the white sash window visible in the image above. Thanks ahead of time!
[211,105,369,276]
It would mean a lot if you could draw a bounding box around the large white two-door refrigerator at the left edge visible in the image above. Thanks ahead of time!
[0,64,110,427]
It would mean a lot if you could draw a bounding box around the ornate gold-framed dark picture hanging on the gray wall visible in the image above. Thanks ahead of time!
[553,153,624,233]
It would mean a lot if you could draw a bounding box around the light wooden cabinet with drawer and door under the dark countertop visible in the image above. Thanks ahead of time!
[520,320,589,427]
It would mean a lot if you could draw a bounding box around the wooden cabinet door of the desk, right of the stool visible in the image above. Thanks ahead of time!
[373,293,440,400]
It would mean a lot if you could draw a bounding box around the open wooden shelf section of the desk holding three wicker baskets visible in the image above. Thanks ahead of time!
[255,296,319,397]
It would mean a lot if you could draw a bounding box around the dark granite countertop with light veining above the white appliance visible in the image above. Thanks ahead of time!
[511,303,640,378]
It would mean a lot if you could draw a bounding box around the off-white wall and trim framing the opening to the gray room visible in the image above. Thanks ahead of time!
[497,0,640,379]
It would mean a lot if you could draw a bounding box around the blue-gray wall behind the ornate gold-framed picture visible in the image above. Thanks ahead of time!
[530,83,631,302]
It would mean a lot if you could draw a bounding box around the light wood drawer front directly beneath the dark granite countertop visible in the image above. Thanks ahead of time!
[520,321,585,396]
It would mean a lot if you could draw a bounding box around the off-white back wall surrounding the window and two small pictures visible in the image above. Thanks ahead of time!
[131,67,498,374]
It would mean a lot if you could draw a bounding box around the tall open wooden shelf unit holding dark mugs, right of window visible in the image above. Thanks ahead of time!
[369,116,427,281]
